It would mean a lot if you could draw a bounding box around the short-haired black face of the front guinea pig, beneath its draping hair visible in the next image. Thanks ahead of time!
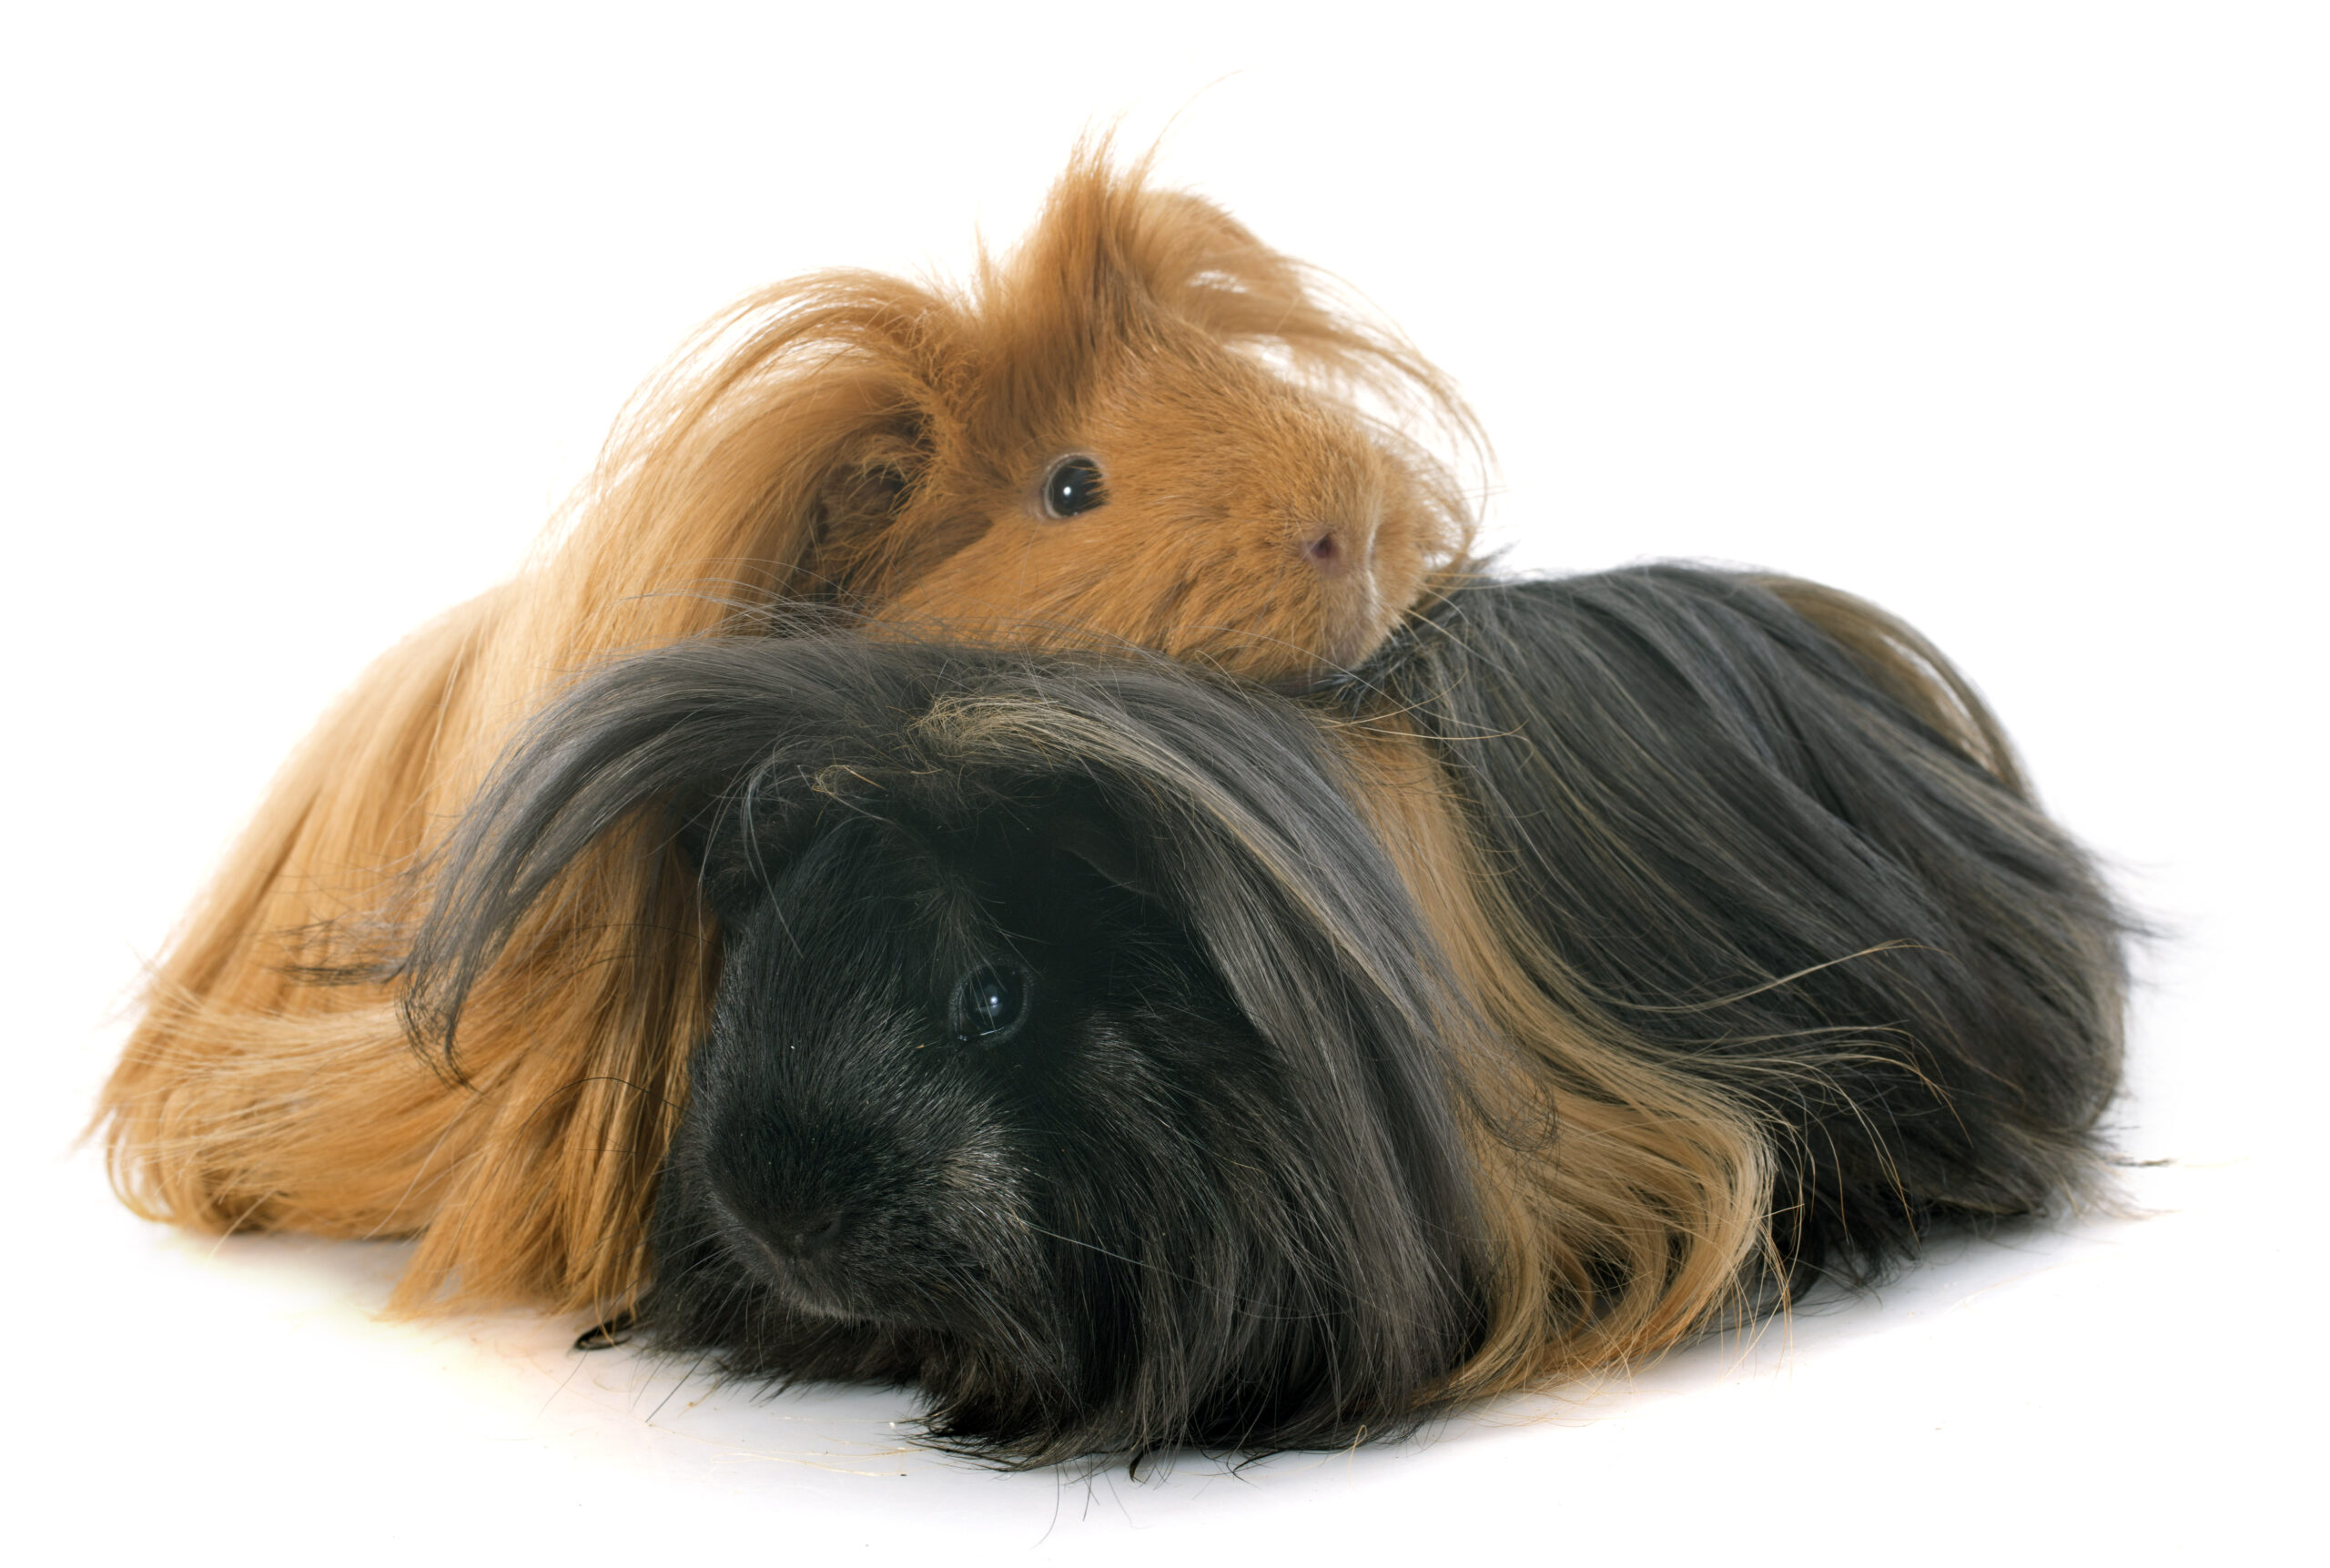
[643,818,1335,1459]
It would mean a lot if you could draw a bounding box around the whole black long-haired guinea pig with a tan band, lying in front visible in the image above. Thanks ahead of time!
[399,569,2121,1463]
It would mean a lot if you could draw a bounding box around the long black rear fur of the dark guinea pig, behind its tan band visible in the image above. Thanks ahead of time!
[1361,566,2125,1284]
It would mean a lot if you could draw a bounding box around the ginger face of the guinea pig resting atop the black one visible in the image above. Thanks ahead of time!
[887,338,1461,681]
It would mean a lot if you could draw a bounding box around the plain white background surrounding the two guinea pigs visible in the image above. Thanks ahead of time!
[0,0,2330,1563]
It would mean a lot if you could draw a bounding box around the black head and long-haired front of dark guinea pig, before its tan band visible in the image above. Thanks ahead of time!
[405,636,1489,1463]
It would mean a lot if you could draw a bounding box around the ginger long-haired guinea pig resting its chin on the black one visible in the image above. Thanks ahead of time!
[100,147,1480,1307]
